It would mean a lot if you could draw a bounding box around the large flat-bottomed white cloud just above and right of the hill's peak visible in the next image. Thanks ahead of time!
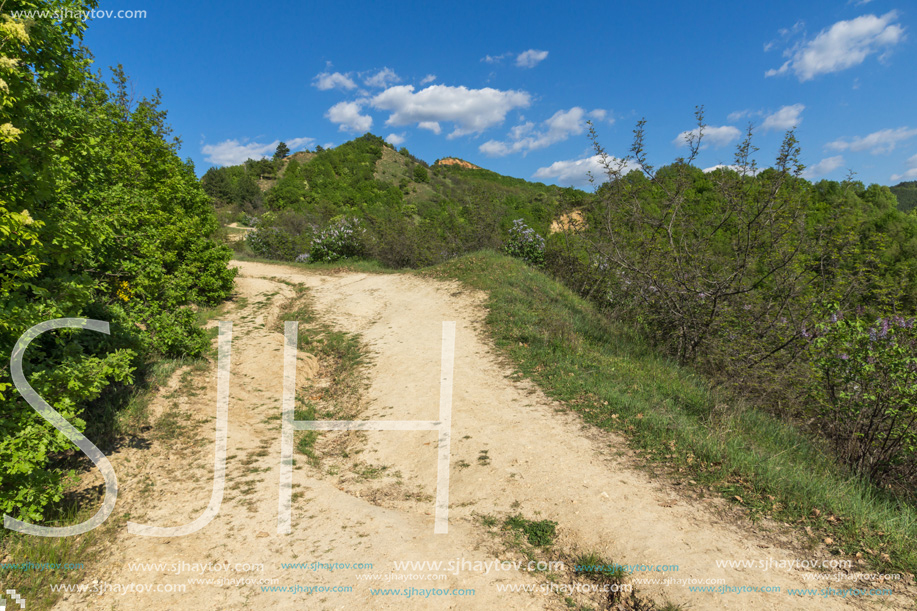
[372,85,532,138]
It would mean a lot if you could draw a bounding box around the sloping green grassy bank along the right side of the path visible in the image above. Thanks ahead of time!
[420,252,917,573]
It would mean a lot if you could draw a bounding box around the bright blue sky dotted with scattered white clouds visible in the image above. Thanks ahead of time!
[84,0,917,186]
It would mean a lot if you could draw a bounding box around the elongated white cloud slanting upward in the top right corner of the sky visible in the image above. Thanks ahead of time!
[764,11,905,82]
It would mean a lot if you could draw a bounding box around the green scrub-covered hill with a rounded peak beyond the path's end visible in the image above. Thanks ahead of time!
[202,134,589,267]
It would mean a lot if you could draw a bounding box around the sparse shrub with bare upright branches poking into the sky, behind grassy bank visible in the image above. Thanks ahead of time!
[590,108,868,402]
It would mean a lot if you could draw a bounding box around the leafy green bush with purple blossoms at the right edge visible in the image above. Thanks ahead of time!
[811,312,917,484]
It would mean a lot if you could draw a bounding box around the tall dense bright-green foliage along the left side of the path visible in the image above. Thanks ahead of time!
[0,1,235,522]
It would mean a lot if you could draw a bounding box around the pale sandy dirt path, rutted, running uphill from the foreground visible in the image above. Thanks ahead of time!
[55,262,904,610]
